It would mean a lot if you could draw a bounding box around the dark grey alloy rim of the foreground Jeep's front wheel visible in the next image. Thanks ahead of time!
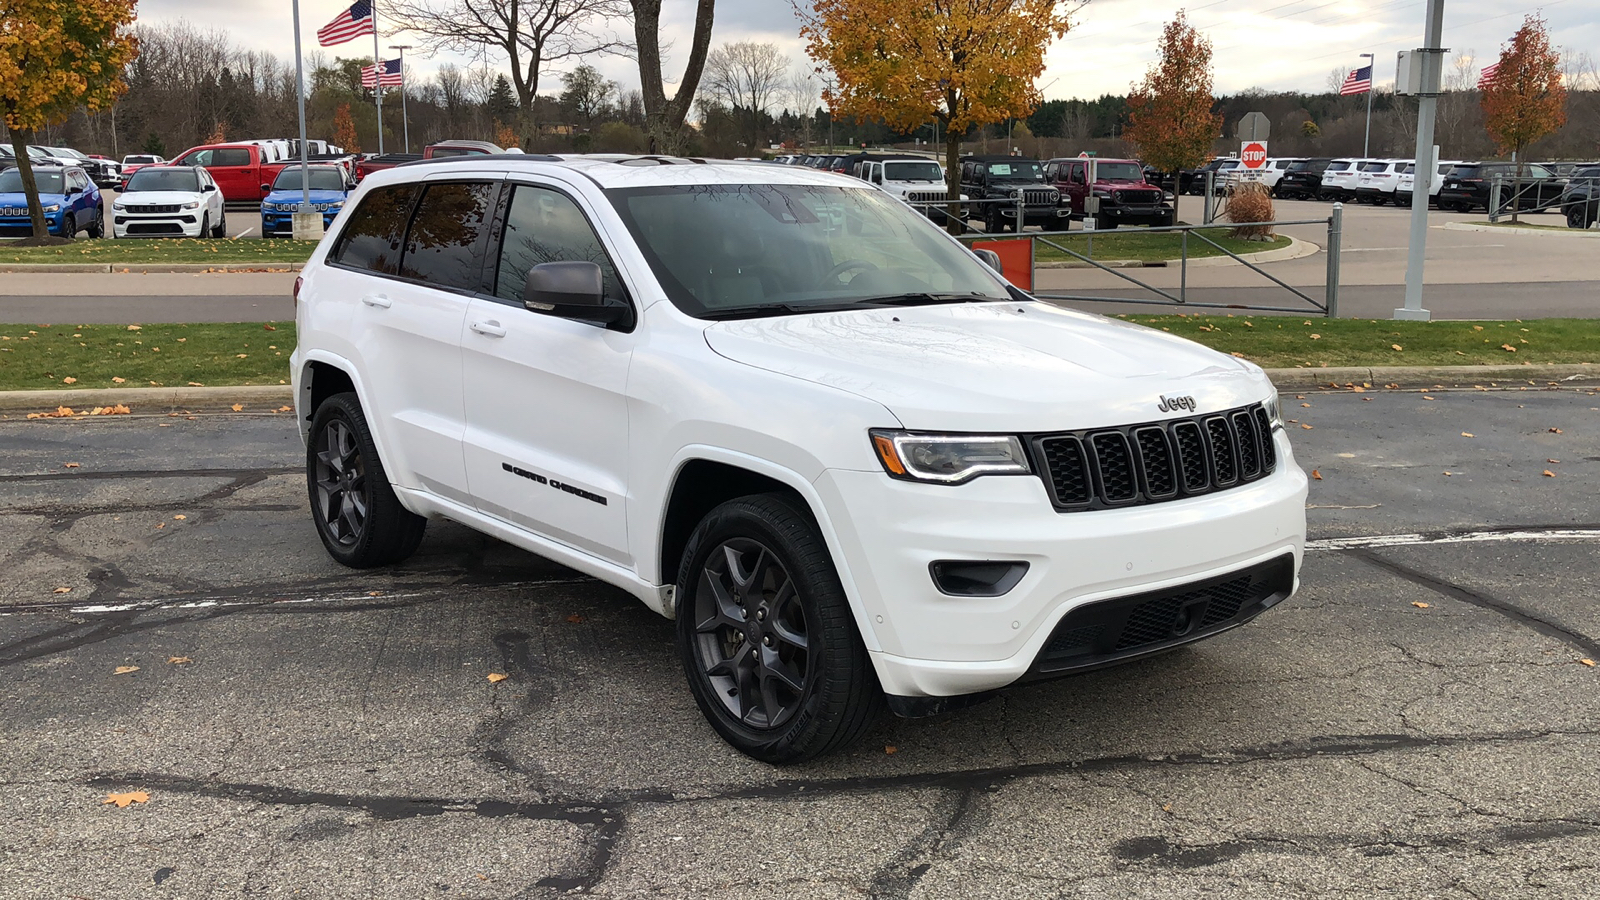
[691,538,811,730]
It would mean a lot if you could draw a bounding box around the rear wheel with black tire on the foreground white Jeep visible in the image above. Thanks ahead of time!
[306,392,427,569]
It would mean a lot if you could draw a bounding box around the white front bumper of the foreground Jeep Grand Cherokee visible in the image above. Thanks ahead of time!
[816,436,1306,697]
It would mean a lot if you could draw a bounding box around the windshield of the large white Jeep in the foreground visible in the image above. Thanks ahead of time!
[606,184,1010,319]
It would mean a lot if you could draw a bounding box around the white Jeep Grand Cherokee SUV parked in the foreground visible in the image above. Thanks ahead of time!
[293,155,1306,762]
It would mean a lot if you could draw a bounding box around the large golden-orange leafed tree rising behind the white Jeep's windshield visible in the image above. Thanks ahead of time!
[795,0,1082,227]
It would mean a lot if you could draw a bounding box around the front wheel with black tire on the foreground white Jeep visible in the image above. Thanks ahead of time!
[677,493,885,765]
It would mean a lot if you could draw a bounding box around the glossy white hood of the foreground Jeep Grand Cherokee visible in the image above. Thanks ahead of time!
[706,303,1270,432]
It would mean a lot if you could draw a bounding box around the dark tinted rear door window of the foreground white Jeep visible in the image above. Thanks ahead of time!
[400,181,498,291]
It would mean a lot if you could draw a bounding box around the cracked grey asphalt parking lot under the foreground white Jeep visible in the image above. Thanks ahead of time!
[0,384,1600,900]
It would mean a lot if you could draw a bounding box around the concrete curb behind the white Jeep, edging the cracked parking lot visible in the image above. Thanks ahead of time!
[0,364,1600,415]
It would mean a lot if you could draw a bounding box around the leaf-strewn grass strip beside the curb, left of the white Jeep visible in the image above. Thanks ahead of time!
[0,322,294,391]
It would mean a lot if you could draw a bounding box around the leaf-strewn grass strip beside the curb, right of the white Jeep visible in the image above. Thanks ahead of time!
[1118,314,1600,368]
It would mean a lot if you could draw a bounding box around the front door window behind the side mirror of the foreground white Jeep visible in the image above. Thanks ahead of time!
[494,184,627,303]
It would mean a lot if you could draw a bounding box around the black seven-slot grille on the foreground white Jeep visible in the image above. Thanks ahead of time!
[1030,404,1278,512]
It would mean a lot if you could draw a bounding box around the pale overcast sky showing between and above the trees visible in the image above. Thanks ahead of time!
[139,0,1600,99]
